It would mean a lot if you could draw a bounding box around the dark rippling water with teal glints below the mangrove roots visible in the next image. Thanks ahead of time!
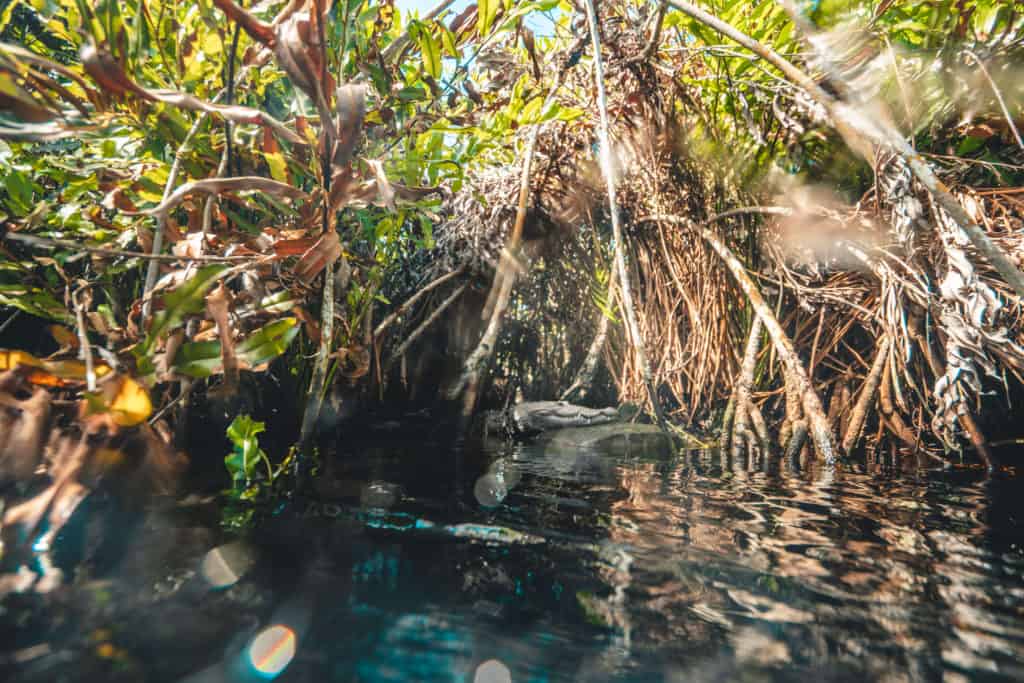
[0,439,1024,683]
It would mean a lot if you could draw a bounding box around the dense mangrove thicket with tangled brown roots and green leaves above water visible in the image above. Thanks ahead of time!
[0,0,1024,511]
